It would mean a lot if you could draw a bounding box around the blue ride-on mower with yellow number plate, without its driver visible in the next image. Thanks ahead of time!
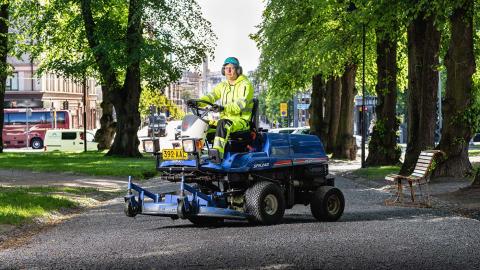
[125,100,345,225]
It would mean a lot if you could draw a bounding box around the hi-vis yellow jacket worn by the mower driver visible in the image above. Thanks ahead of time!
[200,75,253,123]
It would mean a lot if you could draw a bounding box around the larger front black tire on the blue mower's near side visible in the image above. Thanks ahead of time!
[245,181,285,225]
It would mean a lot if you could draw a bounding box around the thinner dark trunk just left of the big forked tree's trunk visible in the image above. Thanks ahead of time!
[95,85,117,150]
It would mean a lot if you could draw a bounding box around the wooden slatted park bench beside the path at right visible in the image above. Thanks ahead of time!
[385,150,443,207]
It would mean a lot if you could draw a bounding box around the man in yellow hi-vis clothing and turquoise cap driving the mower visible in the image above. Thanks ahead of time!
[187,57,253,162]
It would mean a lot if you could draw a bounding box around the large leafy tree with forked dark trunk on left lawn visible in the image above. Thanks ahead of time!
[20,0,215,156]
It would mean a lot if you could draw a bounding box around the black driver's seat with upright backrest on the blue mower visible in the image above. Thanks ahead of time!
[225,98,258,152]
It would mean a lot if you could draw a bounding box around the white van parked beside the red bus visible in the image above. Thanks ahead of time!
[44,129,98,152]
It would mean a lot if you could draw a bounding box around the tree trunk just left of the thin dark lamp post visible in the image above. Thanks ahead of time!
[332,64,357,160]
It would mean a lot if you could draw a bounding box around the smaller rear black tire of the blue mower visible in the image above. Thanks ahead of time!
[310,186,345,221]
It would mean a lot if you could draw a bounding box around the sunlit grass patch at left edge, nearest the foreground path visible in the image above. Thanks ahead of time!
[0,186,116,225]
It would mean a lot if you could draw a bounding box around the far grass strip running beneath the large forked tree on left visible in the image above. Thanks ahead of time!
[0,152,157,179]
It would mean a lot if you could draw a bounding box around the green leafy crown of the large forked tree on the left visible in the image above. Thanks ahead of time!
[15,0,216,89]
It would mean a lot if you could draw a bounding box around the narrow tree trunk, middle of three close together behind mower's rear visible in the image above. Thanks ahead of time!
[325,77,342,153]
